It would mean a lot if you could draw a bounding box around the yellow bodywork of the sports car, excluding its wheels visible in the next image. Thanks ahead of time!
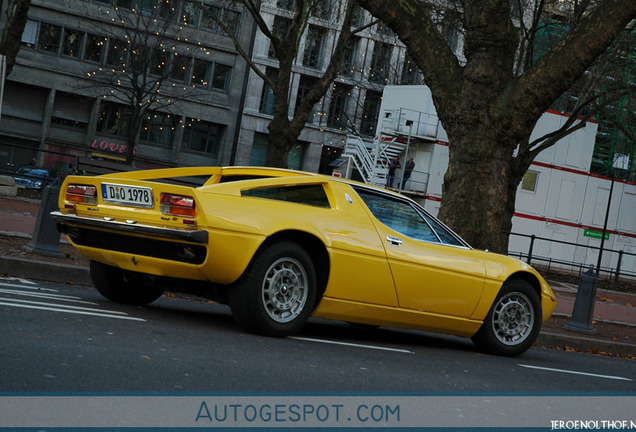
[54,167,556,355]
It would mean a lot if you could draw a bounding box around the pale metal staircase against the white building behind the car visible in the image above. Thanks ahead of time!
[342,134,406,186]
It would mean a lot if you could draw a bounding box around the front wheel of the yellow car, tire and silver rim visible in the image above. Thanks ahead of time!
[472,280,542,357]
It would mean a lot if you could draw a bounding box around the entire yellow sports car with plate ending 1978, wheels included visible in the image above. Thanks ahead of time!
[53,167,556,355]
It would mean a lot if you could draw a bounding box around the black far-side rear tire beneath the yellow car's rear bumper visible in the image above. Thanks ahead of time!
[90,261,164,306]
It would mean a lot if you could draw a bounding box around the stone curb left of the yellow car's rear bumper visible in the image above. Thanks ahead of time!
[0,257,93,286]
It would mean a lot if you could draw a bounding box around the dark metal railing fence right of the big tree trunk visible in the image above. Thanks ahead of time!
[508,232,636,288]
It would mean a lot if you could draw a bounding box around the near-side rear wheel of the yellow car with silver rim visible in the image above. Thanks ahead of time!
[228,241,317,337]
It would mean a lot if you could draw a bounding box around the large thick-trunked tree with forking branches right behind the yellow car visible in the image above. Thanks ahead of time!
[357,0,636,253]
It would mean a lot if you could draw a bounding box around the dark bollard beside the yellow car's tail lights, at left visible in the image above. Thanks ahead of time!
[25,185,64,257]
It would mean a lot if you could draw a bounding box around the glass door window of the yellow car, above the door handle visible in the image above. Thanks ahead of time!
[356,189,439,243]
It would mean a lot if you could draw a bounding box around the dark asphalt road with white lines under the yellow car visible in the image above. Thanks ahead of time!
[0,278,636,393]
